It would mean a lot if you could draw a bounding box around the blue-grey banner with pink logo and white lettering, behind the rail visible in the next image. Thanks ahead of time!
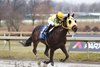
[69,34,100,52]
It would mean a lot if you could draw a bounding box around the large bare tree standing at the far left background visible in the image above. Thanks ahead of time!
[5,0,25,31]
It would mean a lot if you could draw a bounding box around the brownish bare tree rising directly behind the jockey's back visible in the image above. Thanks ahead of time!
[35,0,52,24]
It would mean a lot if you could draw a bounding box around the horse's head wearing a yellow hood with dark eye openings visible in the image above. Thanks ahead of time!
[62,14,77,32]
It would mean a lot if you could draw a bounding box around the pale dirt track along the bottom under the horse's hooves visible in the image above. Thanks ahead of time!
[0,59,100,67]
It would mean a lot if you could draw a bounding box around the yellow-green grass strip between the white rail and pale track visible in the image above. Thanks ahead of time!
[0,41,100,62]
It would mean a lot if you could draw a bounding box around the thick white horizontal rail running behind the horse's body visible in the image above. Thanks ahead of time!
[0,36,100,41]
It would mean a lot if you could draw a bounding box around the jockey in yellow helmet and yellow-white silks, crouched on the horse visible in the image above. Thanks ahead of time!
[46,12,64,34]
